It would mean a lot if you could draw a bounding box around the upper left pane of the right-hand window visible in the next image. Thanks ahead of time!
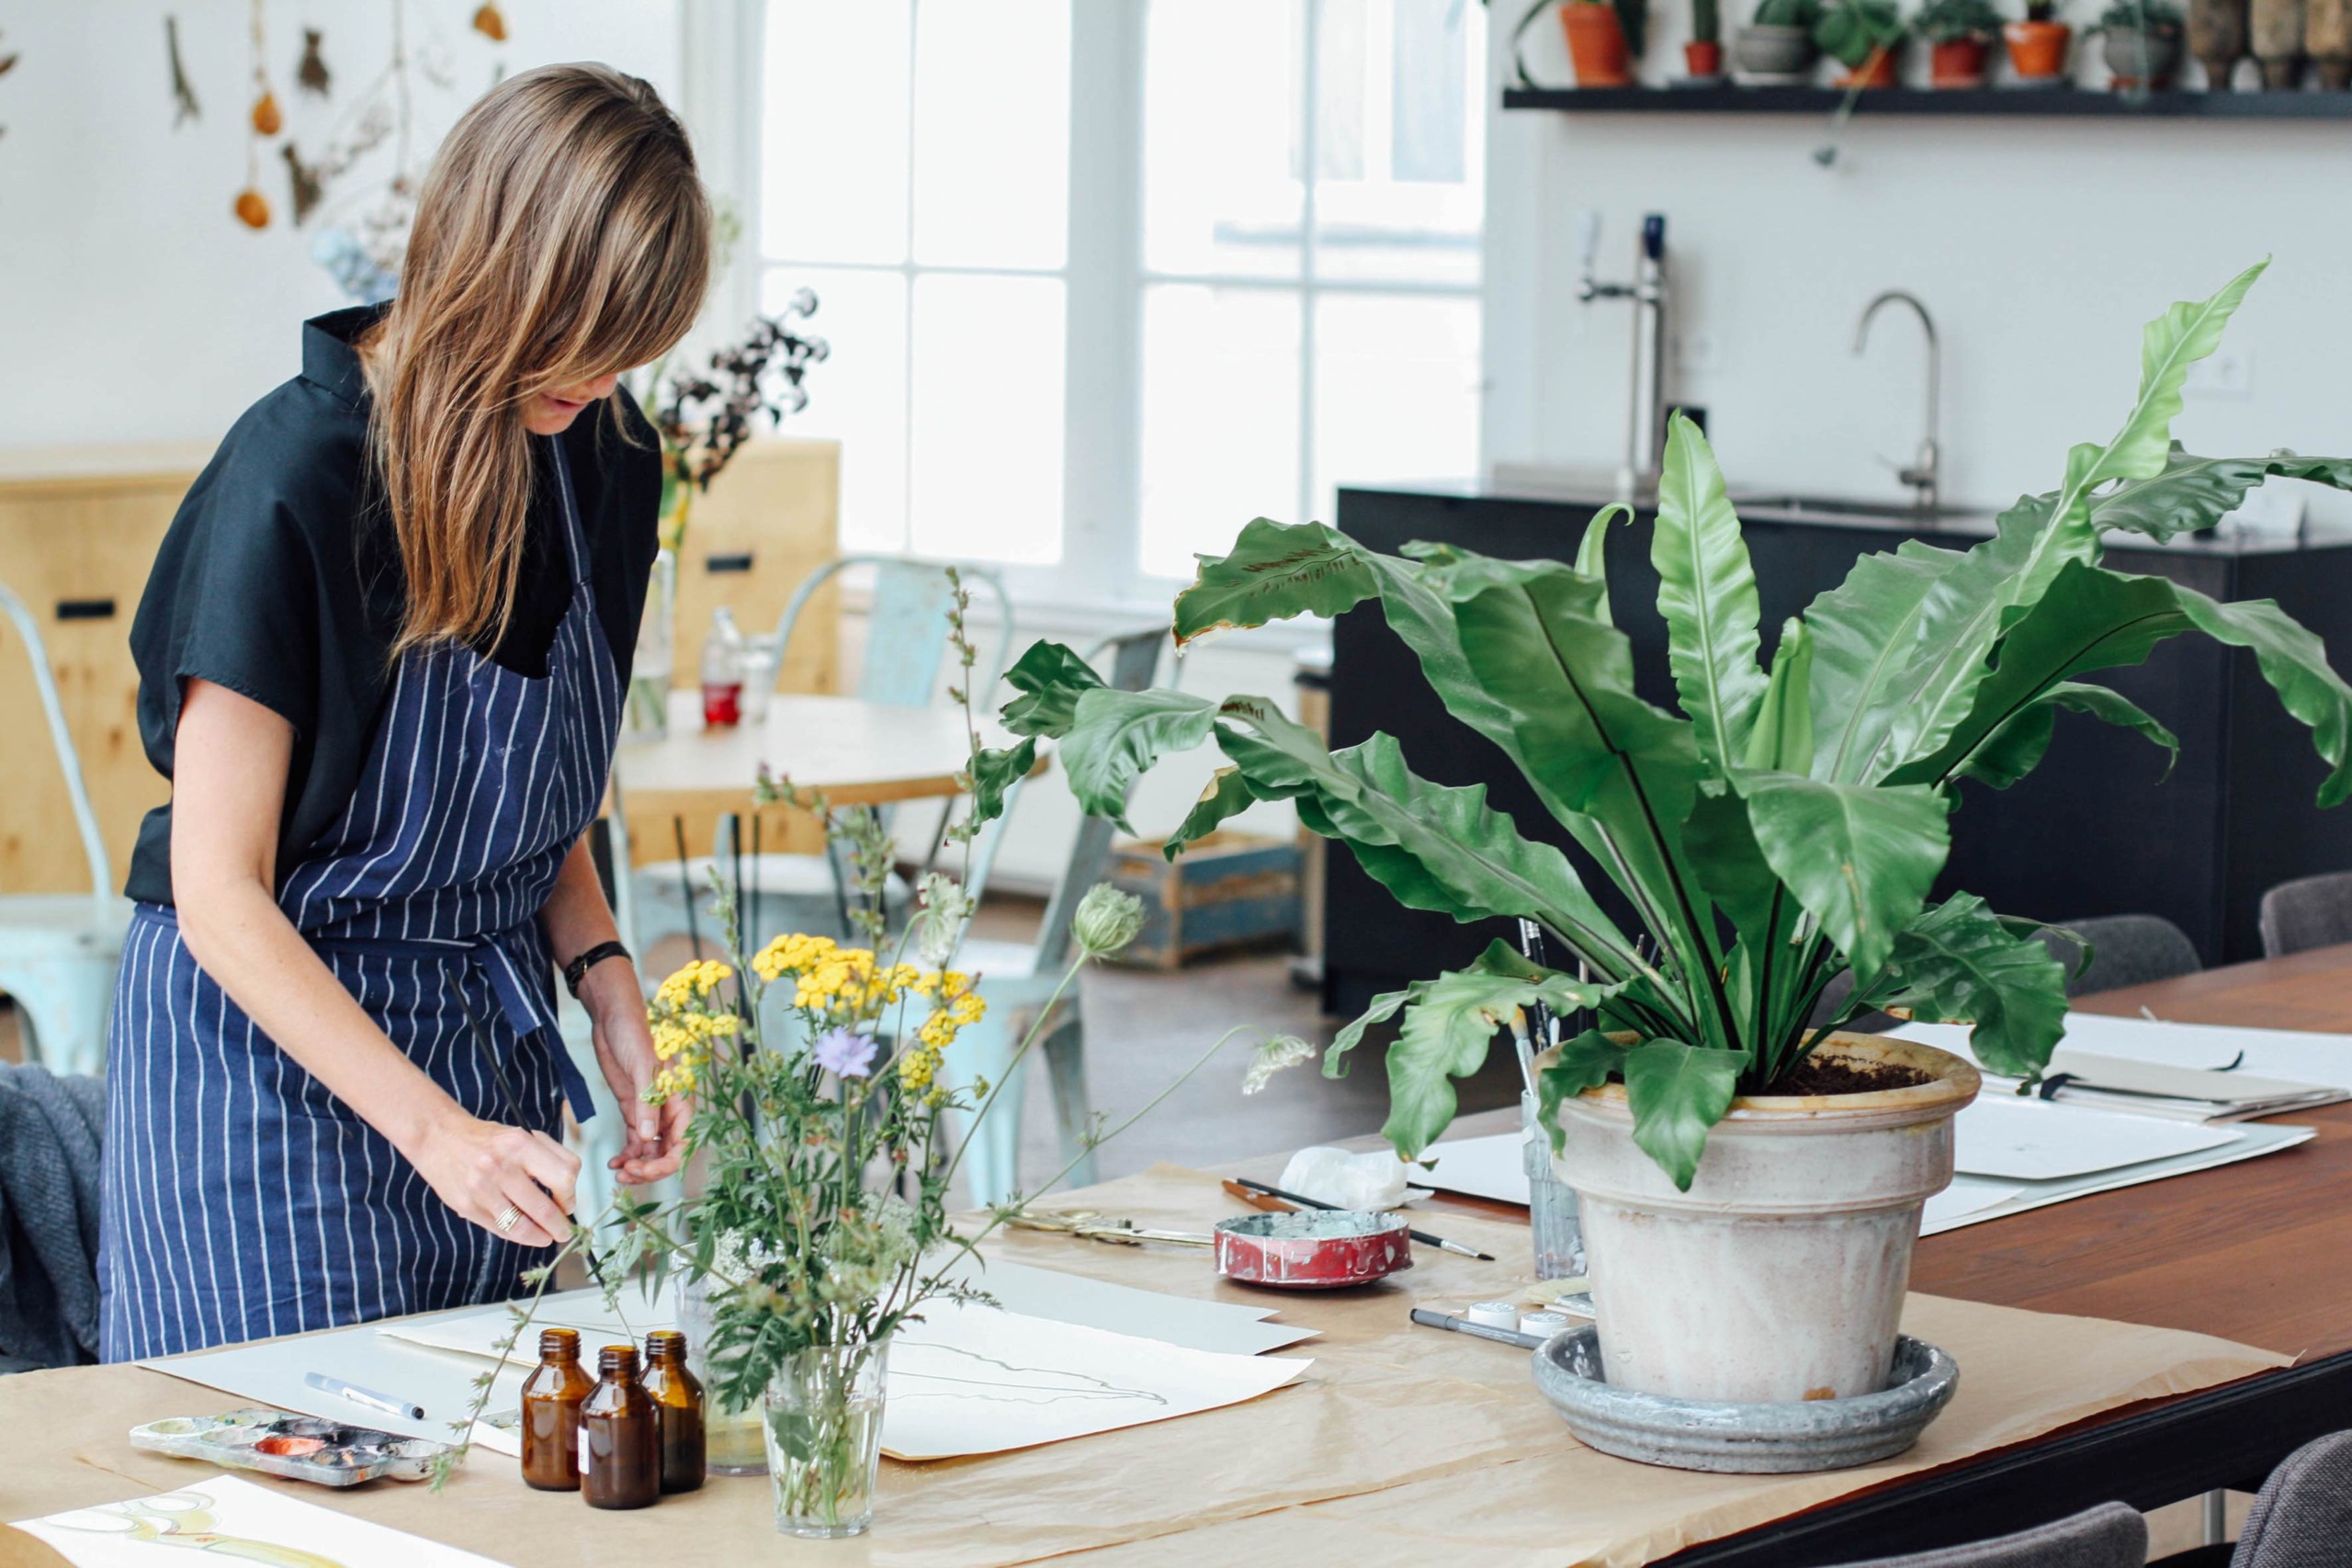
[1143,0,1303,277]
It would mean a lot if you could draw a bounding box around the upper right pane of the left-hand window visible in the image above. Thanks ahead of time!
[912,0,1070,268]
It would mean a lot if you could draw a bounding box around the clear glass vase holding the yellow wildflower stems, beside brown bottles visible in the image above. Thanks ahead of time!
[764,1340,889,1540]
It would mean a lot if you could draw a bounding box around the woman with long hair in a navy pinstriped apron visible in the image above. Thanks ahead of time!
[99,66,710,1361]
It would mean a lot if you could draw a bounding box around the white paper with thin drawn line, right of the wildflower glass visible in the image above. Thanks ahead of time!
[882,1303,1315,1460]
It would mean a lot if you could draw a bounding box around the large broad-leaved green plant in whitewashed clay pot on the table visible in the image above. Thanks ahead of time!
[1004,268,2352,1438]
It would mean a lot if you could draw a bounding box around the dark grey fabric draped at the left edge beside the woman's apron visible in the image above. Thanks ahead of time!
[0,1063,106,1373]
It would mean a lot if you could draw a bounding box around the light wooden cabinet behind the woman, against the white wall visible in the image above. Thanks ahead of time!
[0,437,840,894]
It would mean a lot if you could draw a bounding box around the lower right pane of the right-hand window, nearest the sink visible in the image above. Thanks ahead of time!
[1315,294,1479,522]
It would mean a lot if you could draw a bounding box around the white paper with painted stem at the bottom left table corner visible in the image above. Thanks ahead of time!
[17,1476,499,1568]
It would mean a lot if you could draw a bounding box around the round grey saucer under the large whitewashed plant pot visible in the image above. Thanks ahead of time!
[1533,1324,1959,1474]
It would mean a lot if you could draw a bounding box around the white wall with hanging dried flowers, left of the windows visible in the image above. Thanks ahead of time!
[0,0,684,460]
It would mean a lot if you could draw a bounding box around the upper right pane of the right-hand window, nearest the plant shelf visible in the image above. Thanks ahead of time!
[1315,0,1487,285]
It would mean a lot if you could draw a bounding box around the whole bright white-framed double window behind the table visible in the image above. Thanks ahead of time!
[760,0,1484,602]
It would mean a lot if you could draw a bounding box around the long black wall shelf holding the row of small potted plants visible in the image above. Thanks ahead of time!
[1503,87,2352,120]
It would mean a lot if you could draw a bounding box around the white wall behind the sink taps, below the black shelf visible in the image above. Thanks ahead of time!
[1487,21,2352,513]
